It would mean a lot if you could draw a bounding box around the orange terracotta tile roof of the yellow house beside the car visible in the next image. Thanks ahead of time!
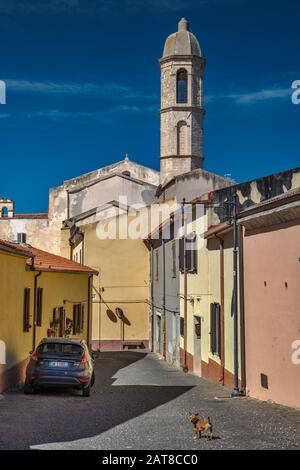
[0,240,98,274]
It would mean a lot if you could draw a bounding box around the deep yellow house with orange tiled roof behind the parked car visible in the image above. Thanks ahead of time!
[0,240,97,392]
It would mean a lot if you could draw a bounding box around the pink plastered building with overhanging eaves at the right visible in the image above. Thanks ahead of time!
[240,188,300,408]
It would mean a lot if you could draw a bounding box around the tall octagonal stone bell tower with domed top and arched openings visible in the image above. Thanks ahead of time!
[159,18,205,183]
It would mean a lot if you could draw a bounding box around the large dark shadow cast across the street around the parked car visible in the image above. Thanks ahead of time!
[0,352,192,449]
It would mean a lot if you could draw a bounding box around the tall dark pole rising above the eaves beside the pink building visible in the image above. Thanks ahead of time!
[231,193,243,397]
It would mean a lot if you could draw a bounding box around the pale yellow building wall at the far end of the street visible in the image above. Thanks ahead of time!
[70,208,149,350]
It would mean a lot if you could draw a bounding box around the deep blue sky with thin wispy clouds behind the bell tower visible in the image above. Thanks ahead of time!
[0,0,300,212]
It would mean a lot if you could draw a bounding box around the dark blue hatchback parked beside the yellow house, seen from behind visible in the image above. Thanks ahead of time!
[24,338,95,397]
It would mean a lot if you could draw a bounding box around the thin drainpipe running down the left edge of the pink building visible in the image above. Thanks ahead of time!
[239,225,246,393]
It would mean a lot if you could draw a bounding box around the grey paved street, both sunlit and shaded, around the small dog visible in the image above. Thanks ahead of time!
[0,352,300,450]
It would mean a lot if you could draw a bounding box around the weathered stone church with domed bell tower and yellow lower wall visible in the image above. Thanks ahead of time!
[0,18,232,350]
